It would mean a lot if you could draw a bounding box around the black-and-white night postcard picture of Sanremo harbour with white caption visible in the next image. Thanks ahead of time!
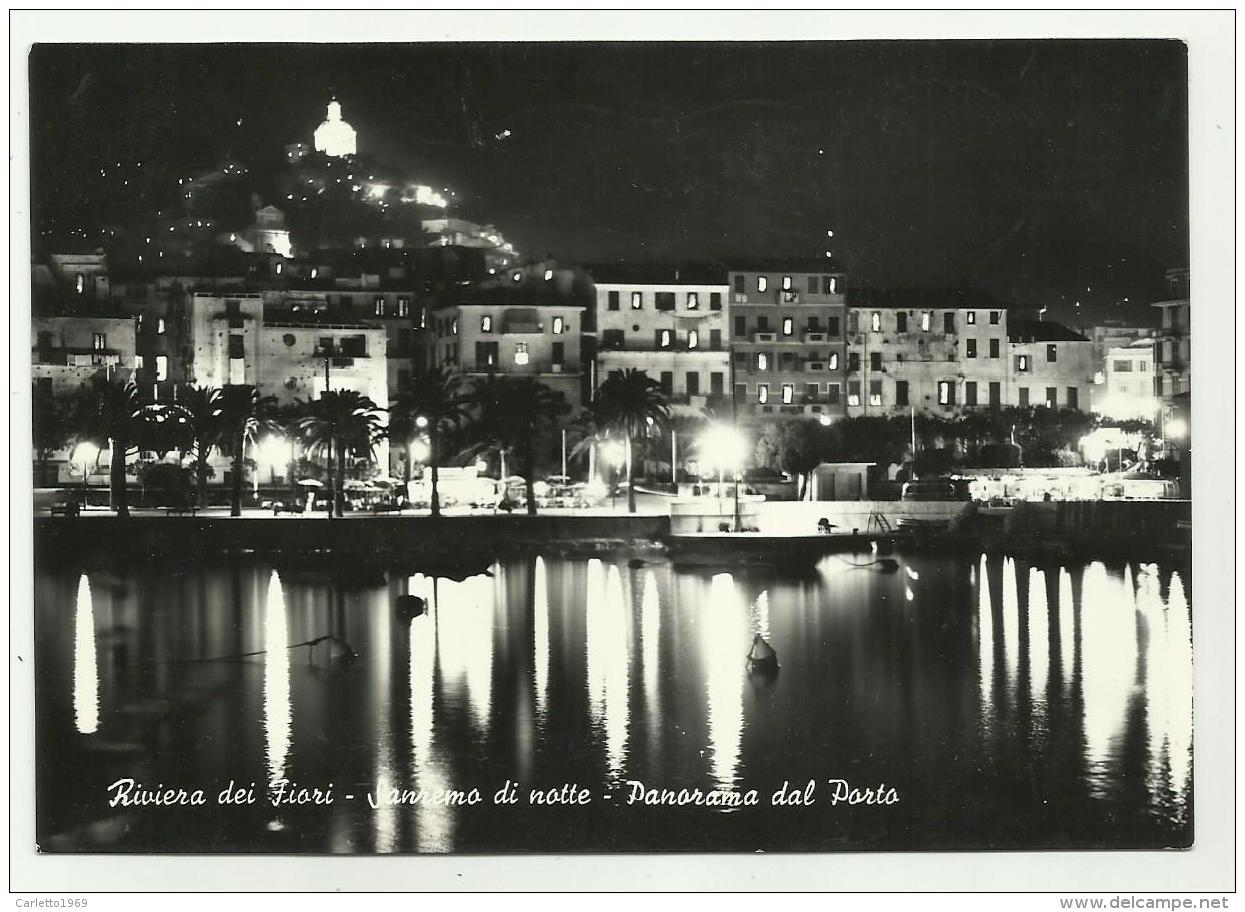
[11,14,1235,895]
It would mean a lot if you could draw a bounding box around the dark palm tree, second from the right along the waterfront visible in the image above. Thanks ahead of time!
[471,376,570,516]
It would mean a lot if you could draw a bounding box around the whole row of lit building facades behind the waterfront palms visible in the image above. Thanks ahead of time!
[32,245,1189,480]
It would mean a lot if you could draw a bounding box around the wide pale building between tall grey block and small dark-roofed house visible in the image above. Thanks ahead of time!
[847,289,1007,417]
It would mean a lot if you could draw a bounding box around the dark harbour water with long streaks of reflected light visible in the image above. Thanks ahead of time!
[36,554,1193,852]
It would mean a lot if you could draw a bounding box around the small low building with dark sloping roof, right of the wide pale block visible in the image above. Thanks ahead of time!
[1006,317,1093,411]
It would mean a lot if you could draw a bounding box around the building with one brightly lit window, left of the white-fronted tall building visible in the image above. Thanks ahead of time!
[423,268,591,413]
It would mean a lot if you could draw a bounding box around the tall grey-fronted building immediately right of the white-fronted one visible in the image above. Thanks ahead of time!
[727,260,847,419]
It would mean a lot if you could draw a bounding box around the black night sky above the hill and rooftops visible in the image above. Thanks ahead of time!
[31,41,1188,323]
